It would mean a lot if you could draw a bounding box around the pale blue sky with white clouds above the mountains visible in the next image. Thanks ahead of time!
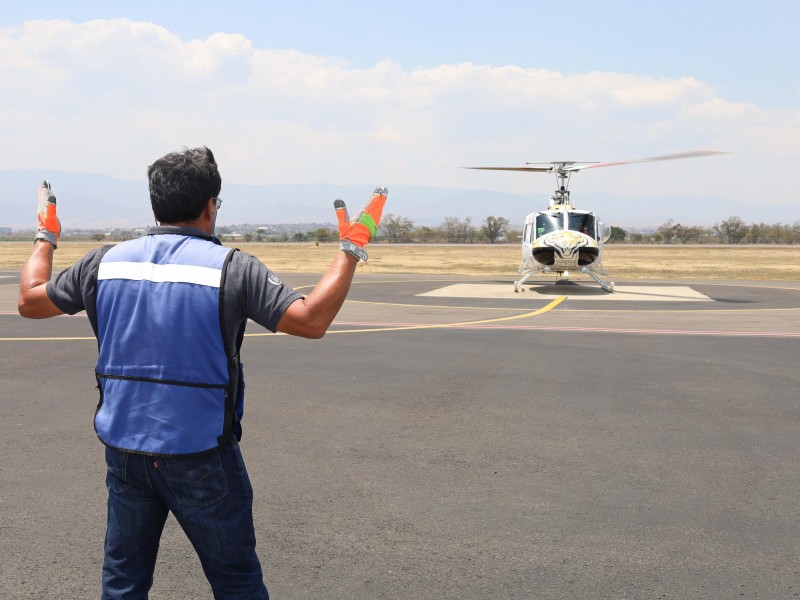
[0,0,800,214]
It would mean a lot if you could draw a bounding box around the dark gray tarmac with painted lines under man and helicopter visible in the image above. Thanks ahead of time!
[0,270,800,600]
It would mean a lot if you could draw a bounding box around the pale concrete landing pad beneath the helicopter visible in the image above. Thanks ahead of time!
[418,283,714,302]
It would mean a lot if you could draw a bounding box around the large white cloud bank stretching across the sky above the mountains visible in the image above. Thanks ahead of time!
[0,19,800,204]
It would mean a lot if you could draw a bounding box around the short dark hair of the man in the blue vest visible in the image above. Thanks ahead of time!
[147,146,222,223]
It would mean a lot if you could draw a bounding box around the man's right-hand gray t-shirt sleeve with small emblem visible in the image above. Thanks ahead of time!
[225,252,302,333]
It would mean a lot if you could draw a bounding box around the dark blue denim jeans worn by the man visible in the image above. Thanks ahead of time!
[102,443,269,600]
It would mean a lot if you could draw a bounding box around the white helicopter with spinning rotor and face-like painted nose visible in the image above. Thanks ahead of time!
[467,150,727,293]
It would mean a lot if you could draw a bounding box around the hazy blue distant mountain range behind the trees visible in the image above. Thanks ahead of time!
[0,169,800,229]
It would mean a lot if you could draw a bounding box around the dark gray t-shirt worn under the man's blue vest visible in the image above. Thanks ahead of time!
[47,227,302,355]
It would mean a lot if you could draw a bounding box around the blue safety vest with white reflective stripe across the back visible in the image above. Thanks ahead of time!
[94,234,244,455]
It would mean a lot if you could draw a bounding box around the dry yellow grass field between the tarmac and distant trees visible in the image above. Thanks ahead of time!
[0,242,800,281]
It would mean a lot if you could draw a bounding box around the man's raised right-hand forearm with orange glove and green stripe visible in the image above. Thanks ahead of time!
[277,188,388,338]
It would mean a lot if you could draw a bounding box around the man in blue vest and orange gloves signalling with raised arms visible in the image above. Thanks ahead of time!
[18,147,387,600]
